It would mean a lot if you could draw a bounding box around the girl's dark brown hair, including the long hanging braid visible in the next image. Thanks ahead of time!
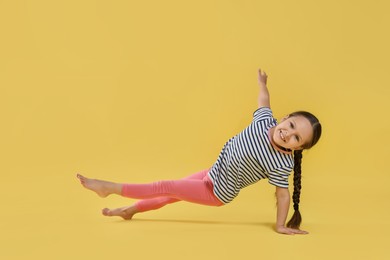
[287,111,322,228]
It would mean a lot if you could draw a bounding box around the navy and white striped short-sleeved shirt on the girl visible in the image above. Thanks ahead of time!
[209,107,294,204]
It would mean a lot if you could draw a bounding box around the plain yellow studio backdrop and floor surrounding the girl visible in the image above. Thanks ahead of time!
[0,0,390,259]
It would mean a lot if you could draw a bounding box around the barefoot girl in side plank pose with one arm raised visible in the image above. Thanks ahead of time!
[77,70,321,235]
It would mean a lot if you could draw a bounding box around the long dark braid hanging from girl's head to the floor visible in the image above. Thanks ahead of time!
[287,150,302,228]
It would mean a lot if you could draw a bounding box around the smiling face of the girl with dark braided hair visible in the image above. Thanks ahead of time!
[271,116,313,150]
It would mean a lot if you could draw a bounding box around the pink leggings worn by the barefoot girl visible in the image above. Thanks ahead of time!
[122,169,223,212]
